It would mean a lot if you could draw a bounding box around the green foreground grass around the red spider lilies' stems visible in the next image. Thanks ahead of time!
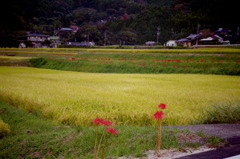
[0,101,223,159]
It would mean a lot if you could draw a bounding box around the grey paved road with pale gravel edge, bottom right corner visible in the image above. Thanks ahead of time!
[118,124,240,159]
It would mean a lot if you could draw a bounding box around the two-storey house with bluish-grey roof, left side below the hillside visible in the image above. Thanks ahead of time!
[27,34,50,48]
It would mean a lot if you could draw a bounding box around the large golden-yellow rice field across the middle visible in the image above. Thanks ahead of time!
[0,67,240,125]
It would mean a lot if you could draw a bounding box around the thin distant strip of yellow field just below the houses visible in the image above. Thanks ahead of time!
[0,47,240,55]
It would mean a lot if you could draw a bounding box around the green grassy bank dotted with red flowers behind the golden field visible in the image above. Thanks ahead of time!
[30,53,240,75]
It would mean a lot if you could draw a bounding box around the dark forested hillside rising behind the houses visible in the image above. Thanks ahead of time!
[0,0,240,47]
